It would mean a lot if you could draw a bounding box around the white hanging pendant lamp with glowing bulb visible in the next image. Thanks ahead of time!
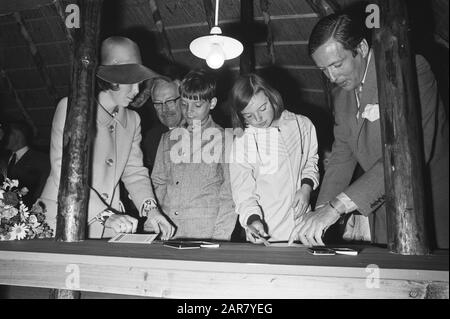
[189,0,244,69]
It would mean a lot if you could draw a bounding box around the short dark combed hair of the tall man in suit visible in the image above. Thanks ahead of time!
[308,14,370,56]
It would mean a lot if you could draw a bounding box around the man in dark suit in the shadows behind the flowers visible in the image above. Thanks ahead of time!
[3,122,50,208]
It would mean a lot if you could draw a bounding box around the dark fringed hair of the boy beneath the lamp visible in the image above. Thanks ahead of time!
[179,70,216,101]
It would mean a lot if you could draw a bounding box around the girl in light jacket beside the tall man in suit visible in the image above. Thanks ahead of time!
[230,74,319,243]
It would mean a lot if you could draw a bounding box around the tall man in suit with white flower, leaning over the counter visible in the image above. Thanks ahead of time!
[291,14,449,249]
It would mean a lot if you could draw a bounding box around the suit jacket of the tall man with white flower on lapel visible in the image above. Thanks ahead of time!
[317,52,449,248]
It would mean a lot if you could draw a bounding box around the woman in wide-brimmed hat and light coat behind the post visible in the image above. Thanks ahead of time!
[41,37,174,239]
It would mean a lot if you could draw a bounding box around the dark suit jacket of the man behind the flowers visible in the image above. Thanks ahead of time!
[0,148,50,208]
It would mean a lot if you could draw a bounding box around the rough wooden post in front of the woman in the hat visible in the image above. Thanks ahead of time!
[56,0,102,242]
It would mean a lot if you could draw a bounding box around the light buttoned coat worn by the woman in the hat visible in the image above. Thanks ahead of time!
[41,98,155,238]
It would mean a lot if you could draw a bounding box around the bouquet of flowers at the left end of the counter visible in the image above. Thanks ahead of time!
[0,178,53,241]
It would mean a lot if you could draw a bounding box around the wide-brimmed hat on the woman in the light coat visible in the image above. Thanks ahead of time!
[97,36,160,84]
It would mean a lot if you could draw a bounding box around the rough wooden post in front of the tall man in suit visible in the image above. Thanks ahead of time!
[374,0,431,255]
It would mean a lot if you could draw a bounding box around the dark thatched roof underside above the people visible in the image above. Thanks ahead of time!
[0,0,448,147]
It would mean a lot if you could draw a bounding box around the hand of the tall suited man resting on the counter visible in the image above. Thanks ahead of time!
[288,205,341,246]
